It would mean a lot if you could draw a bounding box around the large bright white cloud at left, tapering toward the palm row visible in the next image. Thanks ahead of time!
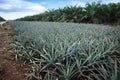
[0,0,47,19]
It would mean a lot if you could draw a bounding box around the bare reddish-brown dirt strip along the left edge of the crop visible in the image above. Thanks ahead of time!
[0,25,29,80]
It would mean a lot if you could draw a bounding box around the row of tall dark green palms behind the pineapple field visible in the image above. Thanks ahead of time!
[17,2,120,24]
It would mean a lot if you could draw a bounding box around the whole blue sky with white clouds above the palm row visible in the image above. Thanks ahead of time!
[0,0,120,20]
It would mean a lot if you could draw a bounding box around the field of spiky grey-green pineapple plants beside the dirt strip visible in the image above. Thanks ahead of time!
[9,21,120,80]
